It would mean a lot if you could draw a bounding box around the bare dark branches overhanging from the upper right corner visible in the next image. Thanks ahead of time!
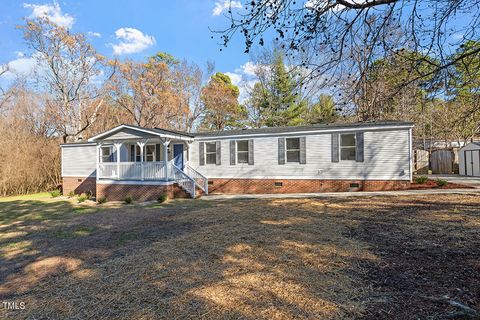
[217,0,480,110]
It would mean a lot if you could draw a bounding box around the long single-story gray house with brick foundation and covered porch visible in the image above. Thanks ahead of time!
[61,121,413,200]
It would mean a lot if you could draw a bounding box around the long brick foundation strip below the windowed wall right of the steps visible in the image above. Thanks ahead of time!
[208,178,410,194]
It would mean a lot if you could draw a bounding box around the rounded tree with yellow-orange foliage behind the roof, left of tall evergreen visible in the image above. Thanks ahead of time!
[201,72,246,130]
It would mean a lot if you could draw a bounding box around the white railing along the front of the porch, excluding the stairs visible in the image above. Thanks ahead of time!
[98,161,167,180]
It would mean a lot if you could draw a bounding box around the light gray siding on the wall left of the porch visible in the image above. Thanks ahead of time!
[62,145,97,177]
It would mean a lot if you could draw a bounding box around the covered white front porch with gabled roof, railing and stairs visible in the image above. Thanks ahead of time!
[90,125,208,197]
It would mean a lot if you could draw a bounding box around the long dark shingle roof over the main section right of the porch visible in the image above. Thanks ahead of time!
[194,121,413,137]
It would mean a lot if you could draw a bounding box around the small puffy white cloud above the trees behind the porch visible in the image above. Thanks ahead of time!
[112,28,155,55]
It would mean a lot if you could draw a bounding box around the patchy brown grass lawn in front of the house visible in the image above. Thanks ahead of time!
[0,195,480,319]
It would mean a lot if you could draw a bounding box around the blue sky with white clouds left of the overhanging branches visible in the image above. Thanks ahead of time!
[0,0,255,85]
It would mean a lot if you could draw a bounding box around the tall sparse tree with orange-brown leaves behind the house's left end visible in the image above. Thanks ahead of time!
[22,18,110,142]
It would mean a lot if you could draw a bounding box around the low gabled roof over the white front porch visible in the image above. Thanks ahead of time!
[88,124,193,142]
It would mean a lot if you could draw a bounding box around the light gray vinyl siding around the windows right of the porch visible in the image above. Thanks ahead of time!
[190,129,410,180]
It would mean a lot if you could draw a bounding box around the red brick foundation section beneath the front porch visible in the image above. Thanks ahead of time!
[96,183,190,201]
